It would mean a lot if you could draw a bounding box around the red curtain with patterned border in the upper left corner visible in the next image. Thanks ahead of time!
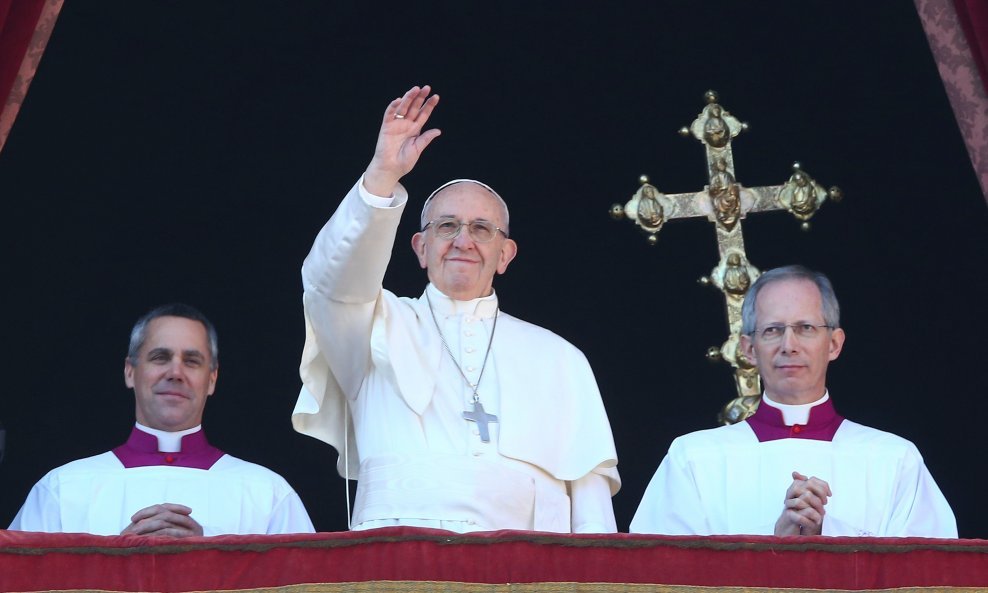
[0,0,63,155]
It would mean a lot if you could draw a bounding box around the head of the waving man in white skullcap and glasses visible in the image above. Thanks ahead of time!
[412,182,518,301]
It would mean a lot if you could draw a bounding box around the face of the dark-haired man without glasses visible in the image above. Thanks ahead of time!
[124,316,218,432]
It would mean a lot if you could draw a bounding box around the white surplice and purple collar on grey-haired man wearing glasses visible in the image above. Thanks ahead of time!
[631,394,957,538]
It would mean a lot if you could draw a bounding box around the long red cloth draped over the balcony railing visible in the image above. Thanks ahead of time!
[0,527,988,593]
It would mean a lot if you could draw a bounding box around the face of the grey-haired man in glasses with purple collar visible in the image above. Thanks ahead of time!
[741,280,844,404]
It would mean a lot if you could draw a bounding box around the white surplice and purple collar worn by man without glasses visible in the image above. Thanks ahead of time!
[10,426,314,535]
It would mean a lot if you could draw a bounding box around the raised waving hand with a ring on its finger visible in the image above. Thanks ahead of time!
[364,85,441,196]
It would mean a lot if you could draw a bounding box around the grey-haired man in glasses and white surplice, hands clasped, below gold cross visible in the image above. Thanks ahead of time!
[631,266,957,538]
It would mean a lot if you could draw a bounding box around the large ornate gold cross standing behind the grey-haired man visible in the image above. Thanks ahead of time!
[611,91,841,424]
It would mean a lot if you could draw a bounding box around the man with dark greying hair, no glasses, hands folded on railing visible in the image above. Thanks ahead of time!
[10,304,313,537]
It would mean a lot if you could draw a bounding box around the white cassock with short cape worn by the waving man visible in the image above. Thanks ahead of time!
[292,179,620,532]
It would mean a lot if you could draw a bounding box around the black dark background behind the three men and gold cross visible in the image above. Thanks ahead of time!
[0,0,988,538]
